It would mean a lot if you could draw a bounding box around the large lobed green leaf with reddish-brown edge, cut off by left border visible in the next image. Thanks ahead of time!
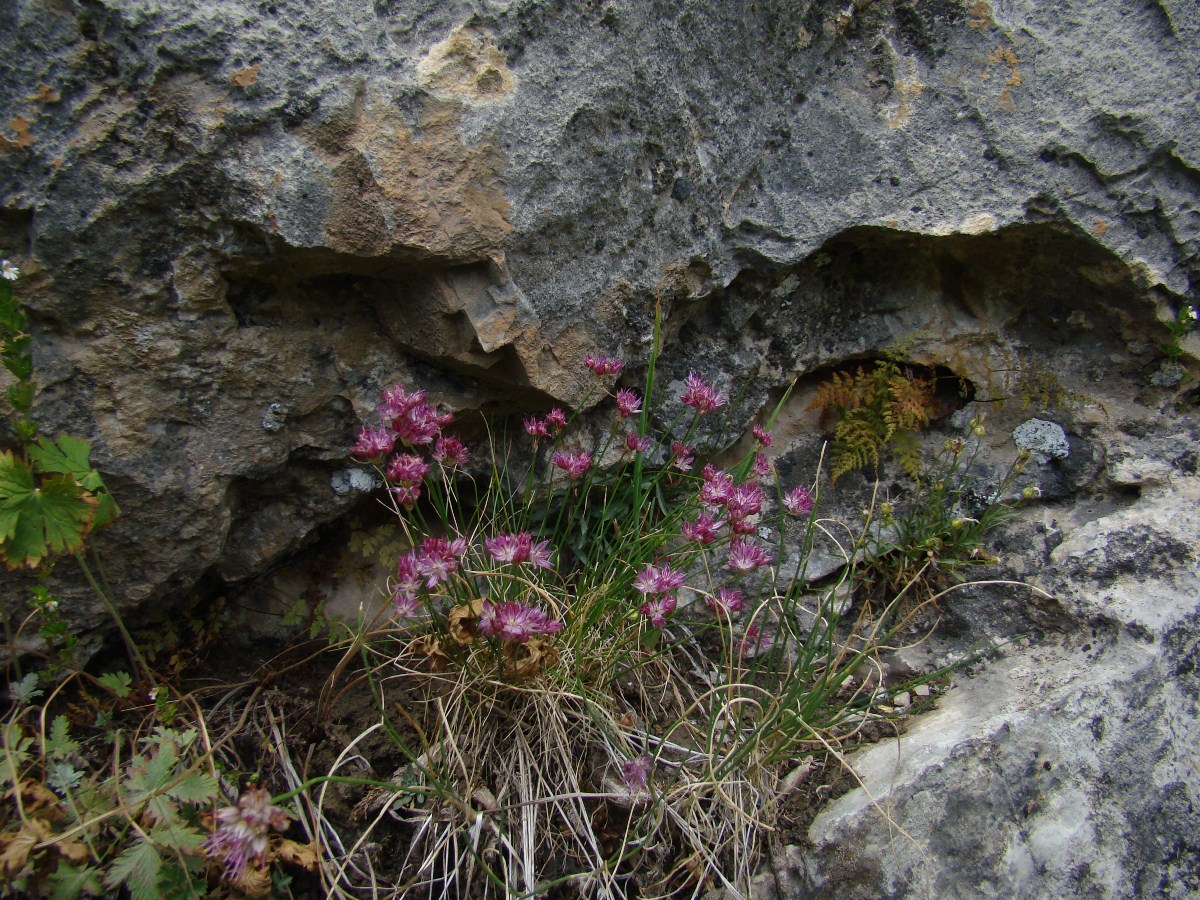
[0,450,97,569]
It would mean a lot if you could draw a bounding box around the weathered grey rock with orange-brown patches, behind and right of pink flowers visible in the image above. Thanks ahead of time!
[0,0,1200,896]
